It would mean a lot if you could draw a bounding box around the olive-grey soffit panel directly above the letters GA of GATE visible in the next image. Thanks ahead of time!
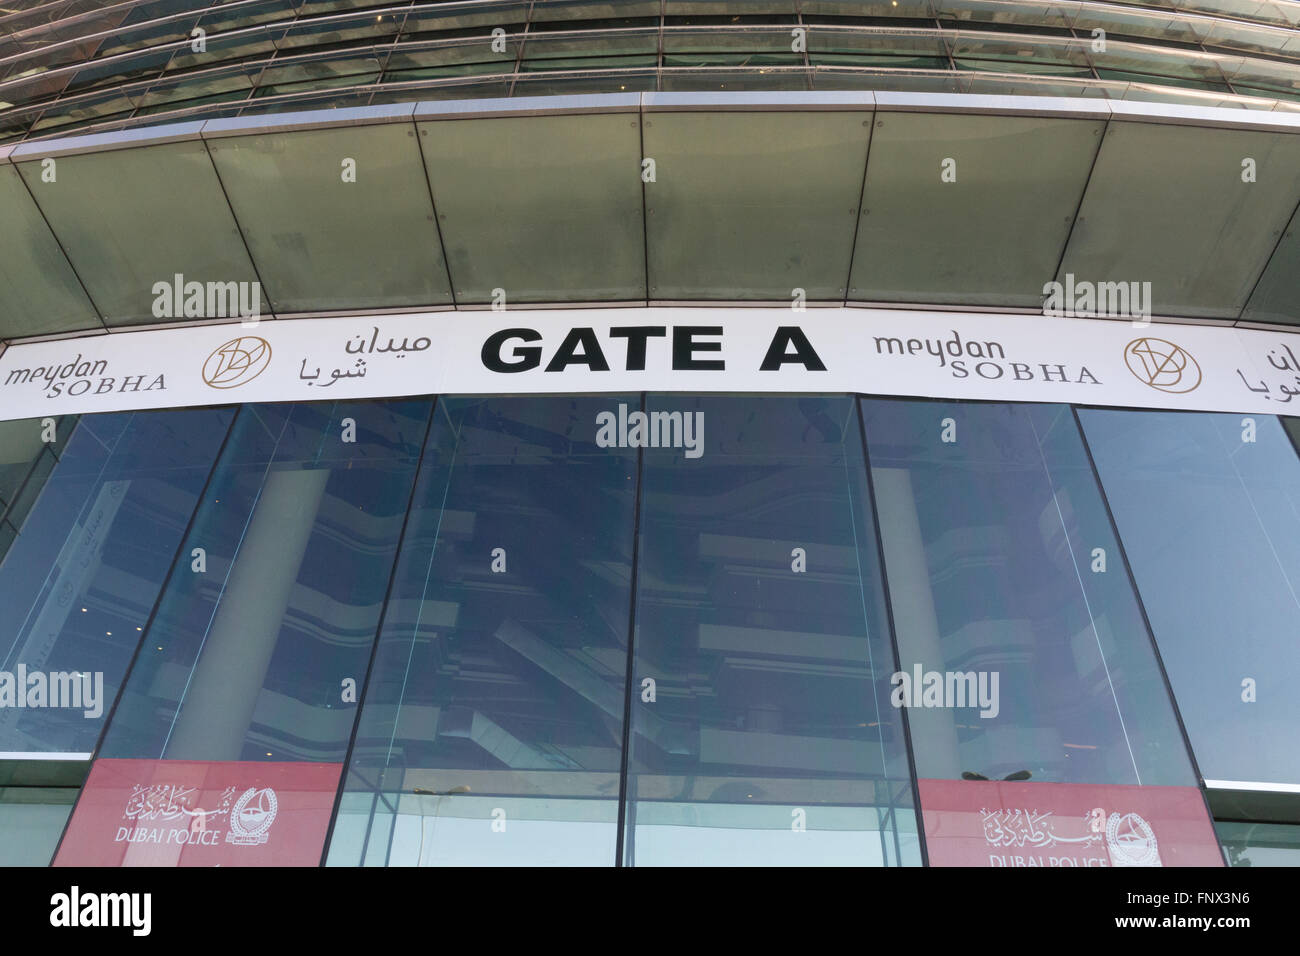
[416,104,646,304]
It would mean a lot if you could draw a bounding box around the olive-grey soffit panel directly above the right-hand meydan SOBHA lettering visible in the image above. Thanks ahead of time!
[849,113,1105,308]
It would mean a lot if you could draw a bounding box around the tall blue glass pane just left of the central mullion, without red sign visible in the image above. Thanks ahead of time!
[329,395,637,866]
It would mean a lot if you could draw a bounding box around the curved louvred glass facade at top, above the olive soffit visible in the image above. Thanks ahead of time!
[0,0,1300,142]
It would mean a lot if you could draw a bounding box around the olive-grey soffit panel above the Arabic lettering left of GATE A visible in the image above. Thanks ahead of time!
[208,122,451,312]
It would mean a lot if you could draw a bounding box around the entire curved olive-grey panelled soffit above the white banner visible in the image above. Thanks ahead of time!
[0,91,1300,341]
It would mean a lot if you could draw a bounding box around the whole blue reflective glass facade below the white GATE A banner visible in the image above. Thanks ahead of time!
[0,393,1300,866]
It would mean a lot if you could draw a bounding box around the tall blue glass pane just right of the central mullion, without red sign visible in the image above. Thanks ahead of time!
[620,395,920,866]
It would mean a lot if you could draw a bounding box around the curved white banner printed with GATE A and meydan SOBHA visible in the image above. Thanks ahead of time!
[0,308,1300,420]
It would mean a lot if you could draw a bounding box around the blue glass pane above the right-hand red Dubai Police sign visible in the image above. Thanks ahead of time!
[862,400,1196,786]
